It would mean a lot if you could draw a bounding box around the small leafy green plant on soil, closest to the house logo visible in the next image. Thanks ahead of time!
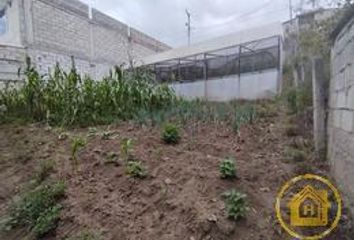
[223,190,249,221]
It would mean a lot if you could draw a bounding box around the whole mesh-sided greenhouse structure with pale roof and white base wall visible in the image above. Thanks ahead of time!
[142,23,282,101]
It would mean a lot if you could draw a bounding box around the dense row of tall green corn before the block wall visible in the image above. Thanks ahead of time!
[0,58,176,126]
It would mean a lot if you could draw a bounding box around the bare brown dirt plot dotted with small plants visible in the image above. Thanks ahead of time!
[0,112,352,240]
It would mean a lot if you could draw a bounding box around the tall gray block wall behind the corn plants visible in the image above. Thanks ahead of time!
[0,0,169,81]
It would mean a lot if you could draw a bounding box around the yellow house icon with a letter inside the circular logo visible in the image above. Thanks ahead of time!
[288,185,331,227]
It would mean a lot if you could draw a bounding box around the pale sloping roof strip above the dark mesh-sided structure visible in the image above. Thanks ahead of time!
[138,22,283,65]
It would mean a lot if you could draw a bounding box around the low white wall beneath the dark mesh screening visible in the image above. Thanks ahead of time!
[170,69,278,102]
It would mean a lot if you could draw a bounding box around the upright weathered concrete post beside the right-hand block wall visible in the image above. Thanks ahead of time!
[312,58,328,161]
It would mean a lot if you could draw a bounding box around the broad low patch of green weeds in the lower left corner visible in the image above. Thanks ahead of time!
[5,182,65,238]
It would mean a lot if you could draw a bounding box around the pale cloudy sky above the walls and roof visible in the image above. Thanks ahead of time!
[82,0,324,47]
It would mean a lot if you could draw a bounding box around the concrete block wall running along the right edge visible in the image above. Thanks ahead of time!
[327,18,354,213]
